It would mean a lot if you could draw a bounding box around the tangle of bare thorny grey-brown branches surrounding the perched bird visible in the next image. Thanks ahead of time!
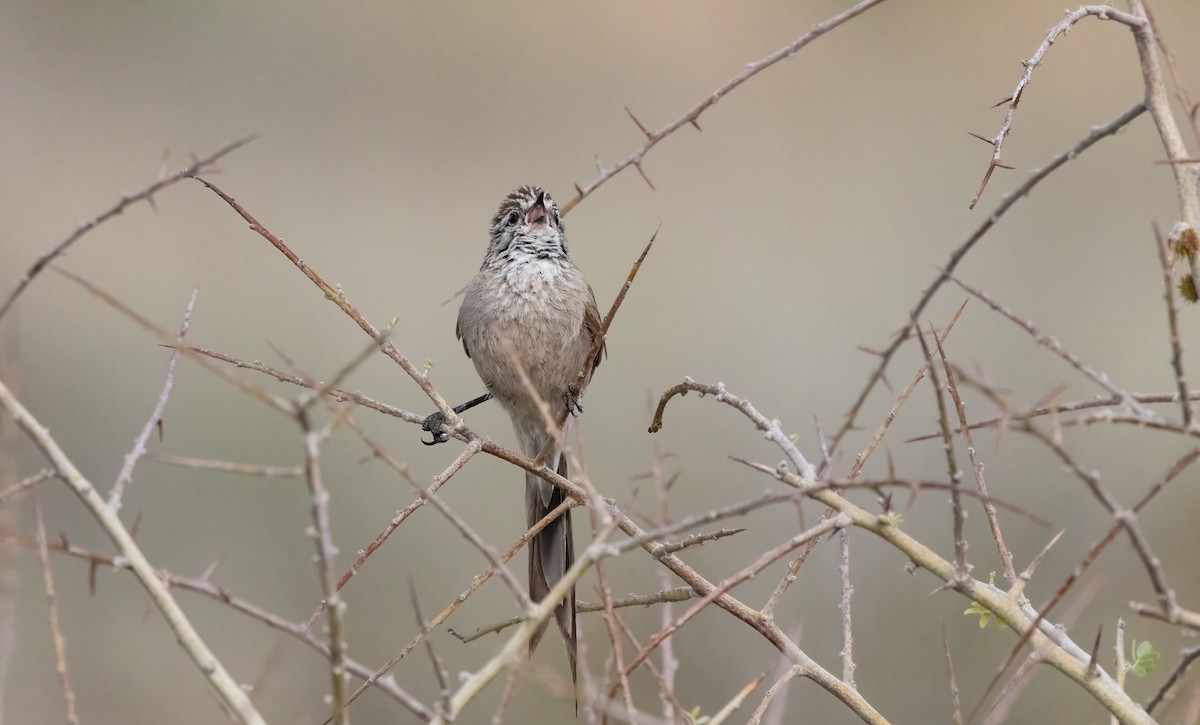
[9,0,1200,723]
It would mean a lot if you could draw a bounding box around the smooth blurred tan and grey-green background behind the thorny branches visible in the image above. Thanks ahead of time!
[0,0,1200,725]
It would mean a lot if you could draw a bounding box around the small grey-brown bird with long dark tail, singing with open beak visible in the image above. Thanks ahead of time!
[448,186,604,681]
